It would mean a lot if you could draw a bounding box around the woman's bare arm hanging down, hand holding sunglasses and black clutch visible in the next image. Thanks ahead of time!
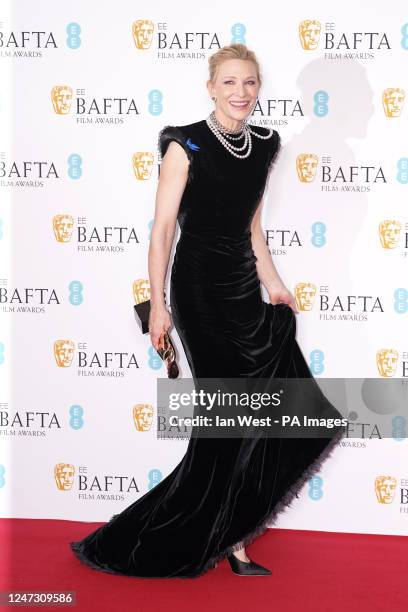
[148,140,189,349]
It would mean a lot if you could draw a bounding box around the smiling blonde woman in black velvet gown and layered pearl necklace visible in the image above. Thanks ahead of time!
[71,44,342,578]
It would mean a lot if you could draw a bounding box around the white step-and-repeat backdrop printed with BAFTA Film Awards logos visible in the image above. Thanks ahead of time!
[0,0,408,535]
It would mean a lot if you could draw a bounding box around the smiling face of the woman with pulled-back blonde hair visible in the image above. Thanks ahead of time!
[207,59,260,121]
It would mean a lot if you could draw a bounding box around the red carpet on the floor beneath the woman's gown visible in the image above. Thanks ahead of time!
[0,519,408,612]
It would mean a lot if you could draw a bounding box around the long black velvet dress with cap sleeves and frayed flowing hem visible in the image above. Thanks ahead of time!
[71,120,343,578]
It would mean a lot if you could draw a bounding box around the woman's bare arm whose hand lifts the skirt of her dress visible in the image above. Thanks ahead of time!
[251,198,299,313]
